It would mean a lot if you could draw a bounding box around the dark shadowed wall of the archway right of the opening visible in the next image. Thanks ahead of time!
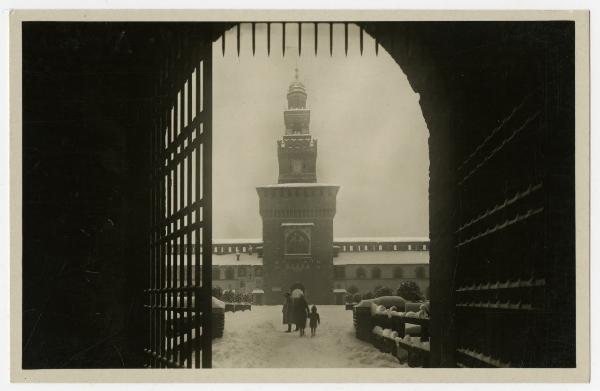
[359,22,575,367]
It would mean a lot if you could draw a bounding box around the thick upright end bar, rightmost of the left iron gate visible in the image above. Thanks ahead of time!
[202,45,212,368]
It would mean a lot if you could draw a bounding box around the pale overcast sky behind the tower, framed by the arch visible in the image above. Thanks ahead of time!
[213,24,429,238]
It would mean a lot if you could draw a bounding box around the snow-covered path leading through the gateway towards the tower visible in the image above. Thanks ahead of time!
[213,305,406,368]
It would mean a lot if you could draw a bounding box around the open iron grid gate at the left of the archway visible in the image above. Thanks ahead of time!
[145,29,212,368]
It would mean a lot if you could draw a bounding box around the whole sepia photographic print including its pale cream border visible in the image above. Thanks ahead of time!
[10,11,590,382]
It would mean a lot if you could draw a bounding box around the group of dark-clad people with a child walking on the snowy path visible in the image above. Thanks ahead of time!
[282,289,321,337]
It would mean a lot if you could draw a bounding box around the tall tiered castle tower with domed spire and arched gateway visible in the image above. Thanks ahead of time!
[256,70,339,304]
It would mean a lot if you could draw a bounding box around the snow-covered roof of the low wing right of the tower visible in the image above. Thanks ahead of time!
[333,251,429,266]
